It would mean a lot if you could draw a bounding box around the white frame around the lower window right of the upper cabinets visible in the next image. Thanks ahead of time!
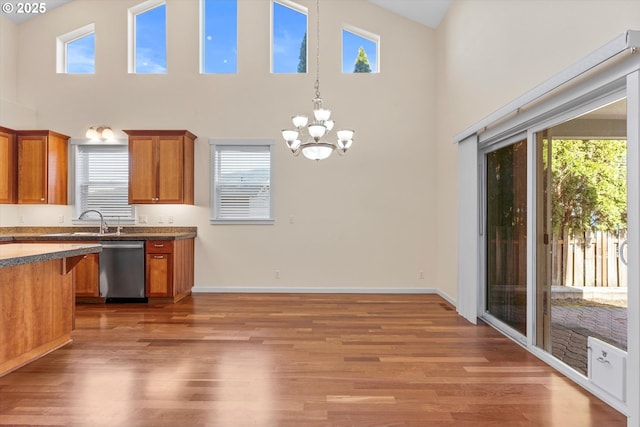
[209,138,275,225]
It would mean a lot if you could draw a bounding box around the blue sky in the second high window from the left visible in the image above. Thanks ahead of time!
[135,4,167,74]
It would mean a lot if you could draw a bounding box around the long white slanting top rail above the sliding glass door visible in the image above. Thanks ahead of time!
[453,30,640,142]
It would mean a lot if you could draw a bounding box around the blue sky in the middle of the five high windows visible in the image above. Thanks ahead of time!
[202,0,238,73]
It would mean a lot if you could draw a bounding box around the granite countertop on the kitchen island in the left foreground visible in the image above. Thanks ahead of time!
[0,243,102,268]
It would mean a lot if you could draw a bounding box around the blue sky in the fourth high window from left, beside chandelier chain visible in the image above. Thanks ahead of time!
[272,1,307,73]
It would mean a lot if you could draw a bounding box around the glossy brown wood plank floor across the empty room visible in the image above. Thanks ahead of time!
[0,294,626,427]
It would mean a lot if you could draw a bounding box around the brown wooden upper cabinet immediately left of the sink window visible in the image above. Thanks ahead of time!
[16,130,69,205]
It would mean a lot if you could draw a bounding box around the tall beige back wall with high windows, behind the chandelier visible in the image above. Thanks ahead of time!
[0,0,438,289]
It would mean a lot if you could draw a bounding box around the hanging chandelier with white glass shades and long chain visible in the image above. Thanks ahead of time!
[282,0,354,160]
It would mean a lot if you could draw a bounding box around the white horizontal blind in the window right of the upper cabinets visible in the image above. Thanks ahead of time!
[211,144,273,223]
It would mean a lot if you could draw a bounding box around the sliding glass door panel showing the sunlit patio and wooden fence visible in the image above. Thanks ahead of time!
[535,99,627,375]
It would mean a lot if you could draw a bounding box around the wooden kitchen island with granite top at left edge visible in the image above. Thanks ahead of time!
[0,243,102,376]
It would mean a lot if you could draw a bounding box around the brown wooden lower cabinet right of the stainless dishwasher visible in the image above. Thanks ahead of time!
[145,239,194,302]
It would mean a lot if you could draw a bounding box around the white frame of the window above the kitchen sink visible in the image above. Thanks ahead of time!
[69,138,137,227]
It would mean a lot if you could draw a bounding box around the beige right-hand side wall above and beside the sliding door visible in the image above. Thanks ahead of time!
[435,0,640,302]
